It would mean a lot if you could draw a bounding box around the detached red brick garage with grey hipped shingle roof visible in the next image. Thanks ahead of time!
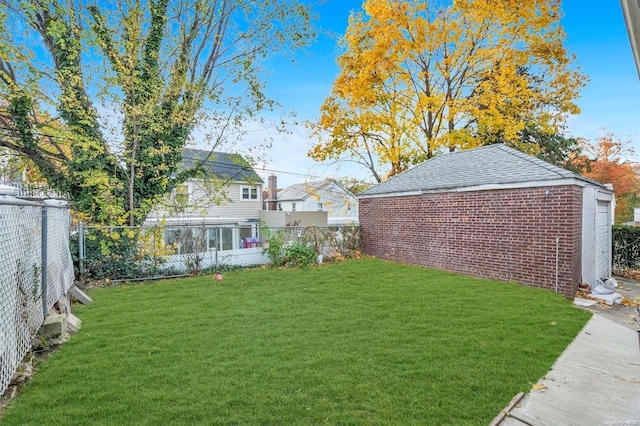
[359,144,613,297]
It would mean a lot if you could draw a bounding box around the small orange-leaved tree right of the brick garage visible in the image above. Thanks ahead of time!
[574,133,640,223]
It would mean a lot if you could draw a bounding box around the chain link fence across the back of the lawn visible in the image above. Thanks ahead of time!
[72,224,360,281]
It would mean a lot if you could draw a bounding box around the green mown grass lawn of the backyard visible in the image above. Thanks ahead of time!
[2,259,589,425]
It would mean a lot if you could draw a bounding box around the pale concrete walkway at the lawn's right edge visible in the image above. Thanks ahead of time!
[500,315,640,426]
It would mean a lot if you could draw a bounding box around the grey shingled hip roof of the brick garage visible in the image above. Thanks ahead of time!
[360,144,604,196]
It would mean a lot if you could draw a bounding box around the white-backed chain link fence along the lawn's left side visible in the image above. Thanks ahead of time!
[0,195,74,395]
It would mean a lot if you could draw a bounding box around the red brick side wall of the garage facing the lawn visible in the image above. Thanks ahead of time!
[360,185,582,297]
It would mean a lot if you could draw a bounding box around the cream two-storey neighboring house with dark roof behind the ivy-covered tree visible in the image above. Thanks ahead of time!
[146,149,264,253]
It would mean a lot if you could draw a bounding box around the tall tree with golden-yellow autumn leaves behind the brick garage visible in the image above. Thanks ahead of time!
[309,0,586,181]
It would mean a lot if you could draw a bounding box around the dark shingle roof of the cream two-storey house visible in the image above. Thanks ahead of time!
[181,148,264,183]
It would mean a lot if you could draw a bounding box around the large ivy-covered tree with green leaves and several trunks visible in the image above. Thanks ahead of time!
[0,0,314,225]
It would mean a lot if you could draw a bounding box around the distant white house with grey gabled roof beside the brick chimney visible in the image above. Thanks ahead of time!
[267,179,358,225]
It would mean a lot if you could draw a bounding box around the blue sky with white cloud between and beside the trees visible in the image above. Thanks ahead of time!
[247,0,640,187]
